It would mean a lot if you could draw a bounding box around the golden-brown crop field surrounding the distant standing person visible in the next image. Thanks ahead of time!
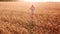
[0,3,60,34]
